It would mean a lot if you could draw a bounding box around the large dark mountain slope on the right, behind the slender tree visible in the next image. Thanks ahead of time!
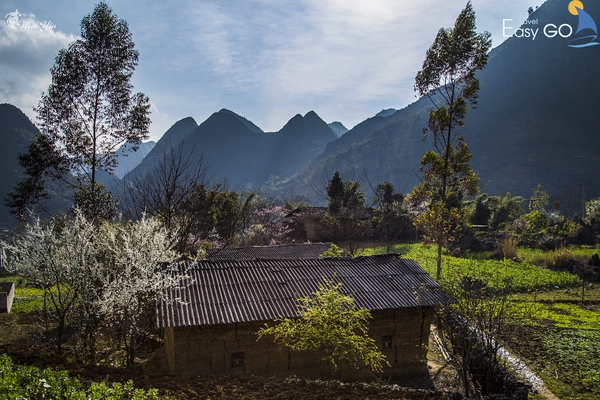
[280,0,600,211]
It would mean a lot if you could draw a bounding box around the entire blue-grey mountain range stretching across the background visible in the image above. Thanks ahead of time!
[0,0,600,220]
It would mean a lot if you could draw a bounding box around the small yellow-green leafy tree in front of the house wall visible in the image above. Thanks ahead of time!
[259,280,387,371]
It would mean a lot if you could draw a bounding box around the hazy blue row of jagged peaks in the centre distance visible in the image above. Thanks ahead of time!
[125,109,341,190]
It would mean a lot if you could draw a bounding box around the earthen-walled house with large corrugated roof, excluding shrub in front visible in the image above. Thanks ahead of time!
[157,255,448,379]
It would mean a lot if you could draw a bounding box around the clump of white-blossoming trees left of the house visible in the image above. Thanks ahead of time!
[1,210,181,364]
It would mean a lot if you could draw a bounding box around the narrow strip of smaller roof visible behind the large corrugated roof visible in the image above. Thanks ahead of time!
[206,243,340,261]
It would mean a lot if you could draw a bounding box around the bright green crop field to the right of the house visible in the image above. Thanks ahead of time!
[363,244,600,400]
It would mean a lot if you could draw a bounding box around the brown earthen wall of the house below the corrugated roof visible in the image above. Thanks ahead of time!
[165,308,433,380]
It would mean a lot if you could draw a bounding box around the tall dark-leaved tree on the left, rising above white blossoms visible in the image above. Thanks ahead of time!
[9,2,150,222]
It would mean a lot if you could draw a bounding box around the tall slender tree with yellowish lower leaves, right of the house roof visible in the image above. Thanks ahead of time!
[410,2,491,279]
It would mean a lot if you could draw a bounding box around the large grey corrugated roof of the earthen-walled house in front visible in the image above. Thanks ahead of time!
[157,254,449,328]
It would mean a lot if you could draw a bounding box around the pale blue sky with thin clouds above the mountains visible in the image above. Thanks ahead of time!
[0,0,542,140]
